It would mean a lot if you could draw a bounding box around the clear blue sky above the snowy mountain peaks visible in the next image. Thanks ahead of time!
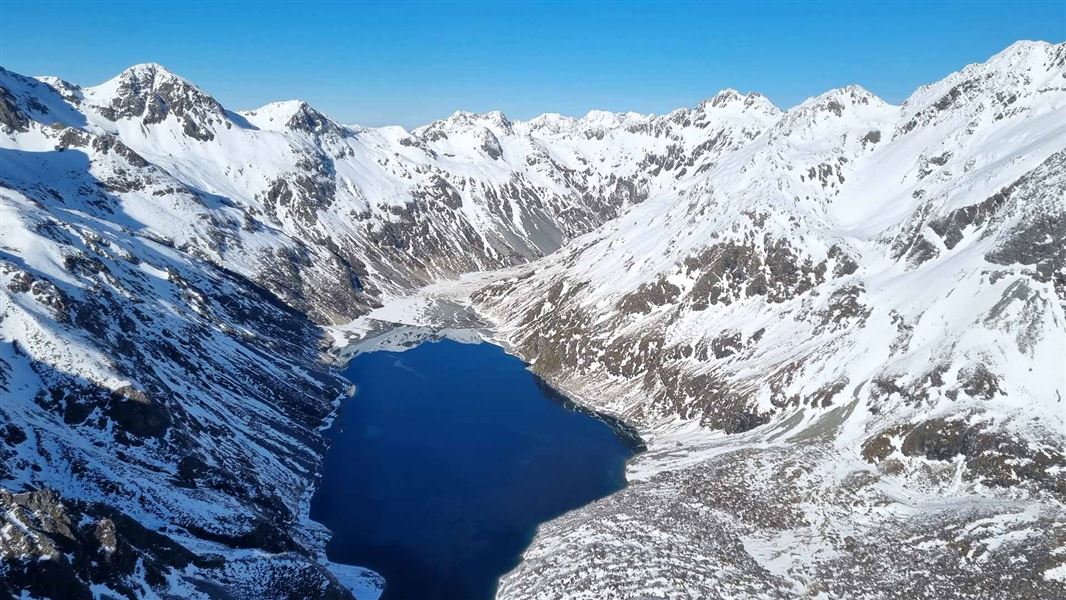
[0,0,1066,127]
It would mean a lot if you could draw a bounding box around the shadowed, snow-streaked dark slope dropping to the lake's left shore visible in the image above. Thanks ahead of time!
[0,182,379,597]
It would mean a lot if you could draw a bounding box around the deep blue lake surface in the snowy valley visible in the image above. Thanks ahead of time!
[311,340,639,600]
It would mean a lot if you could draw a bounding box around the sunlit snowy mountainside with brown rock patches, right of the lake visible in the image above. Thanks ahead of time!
[474,43,1066,598]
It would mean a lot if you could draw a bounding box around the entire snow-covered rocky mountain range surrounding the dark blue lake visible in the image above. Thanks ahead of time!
[0,43,1066,598]
